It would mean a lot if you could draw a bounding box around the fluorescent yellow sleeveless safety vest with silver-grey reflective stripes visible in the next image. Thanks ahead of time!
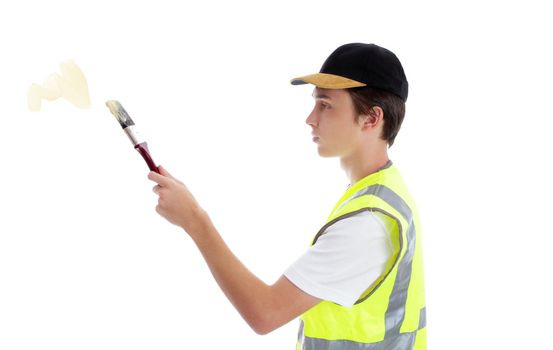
[296,162,426,350]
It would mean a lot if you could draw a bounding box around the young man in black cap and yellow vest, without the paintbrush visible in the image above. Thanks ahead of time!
[148,43,426,350]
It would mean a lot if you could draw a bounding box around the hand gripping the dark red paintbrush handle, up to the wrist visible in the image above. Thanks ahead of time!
[148,166,207,234]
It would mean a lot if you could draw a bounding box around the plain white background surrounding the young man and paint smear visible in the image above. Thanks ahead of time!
[0,0,553,350]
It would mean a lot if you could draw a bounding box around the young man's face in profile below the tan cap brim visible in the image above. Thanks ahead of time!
[305,87,362,157]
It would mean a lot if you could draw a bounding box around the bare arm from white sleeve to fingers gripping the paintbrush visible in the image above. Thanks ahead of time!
[148,166,321,334]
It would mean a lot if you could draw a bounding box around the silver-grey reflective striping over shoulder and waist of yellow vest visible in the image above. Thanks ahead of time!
[301,185,426,350]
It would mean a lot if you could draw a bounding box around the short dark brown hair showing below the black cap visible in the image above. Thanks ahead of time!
[345,86,405,147]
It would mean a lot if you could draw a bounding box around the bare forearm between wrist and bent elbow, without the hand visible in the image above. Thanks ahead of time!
[189,214,271,333]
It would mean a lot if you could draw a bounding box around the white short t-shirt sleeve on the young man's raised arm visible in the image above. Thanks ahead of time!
[284,211,397,307]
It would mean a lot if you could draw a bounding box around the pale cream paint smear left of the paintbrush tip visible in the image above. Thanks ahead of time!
[27,60,90,112]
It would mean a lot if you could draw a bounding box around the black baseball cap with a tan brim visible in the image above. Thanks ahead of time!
[290,43,409,102]
